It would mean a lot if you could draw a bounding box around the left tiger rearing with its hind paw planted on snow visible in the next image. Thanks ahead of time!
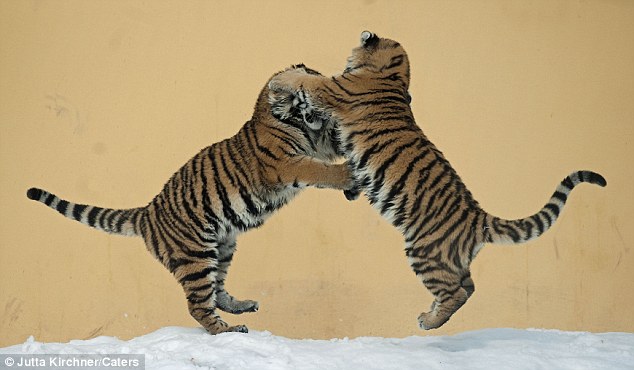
[27,65,354,334]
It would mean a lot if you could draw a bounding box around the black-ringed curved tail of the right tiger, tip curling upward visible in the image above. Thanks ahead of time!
[484,171,607,243]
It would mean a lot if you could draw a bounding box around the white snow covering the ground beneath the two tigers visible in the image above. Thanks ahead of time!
[0,327,634,370]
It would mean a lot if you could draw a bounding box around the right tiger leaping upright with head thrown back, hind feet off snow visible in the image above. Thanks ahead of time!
[269,31,607,330]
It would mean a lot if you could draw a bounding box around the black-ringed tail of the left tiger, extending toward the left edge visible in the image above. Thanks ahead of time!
[26,188,146,236]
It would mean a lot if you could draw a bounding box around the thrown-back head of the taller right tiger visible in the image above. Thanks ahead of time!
[344,31,410,97]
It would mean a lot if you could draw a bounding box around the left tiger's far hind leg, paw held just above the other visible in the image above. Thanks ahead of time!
[216,240,260,315]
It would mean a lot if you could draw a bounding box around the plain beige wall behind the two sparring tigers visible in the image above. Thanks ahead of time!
[0,0,634,346]
